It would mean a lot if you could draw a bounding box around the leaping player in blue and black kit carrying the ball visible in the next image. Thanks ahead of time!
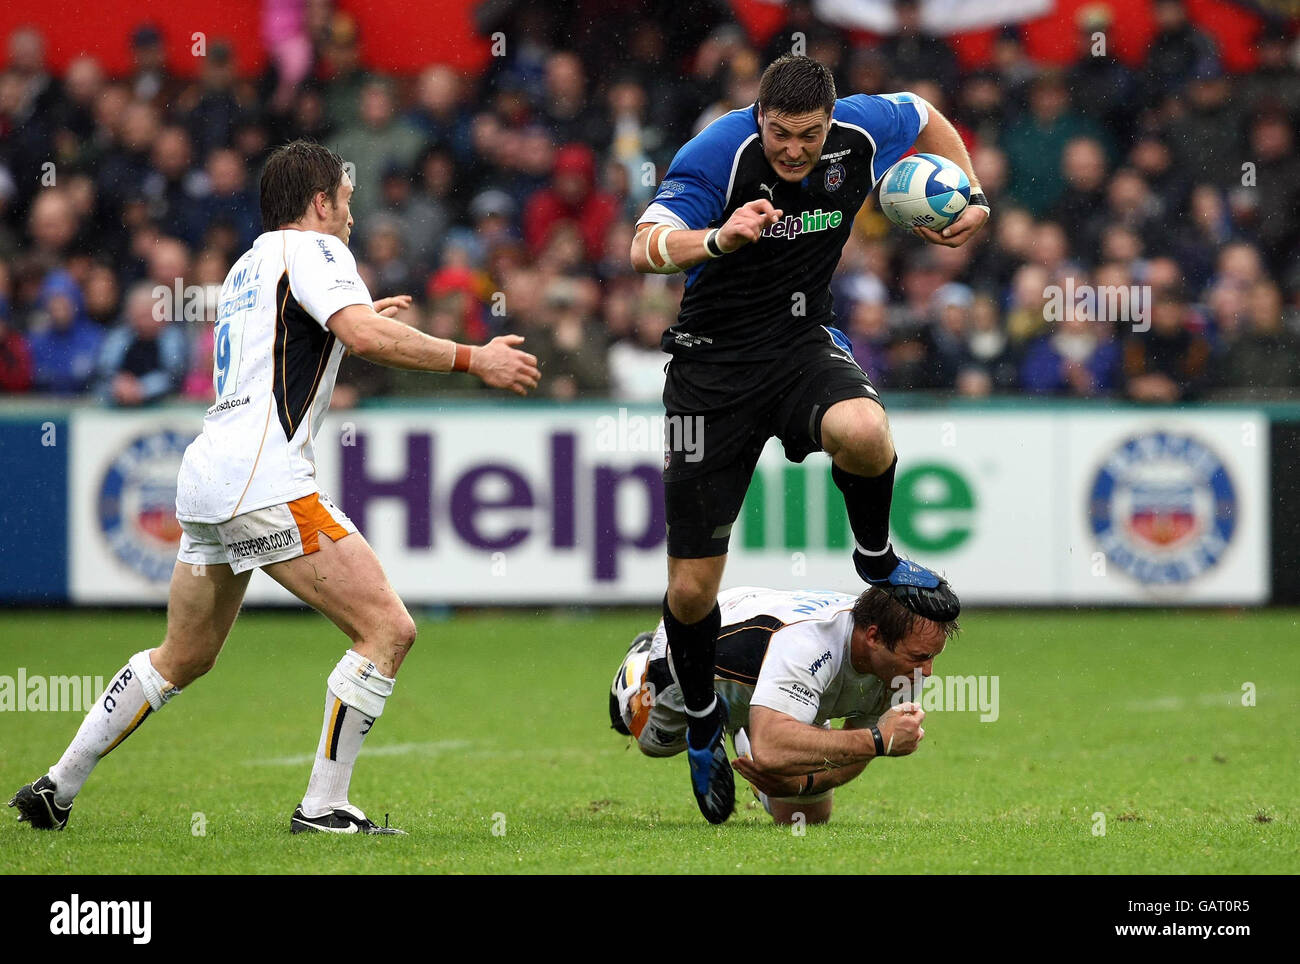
[632,55,989,824]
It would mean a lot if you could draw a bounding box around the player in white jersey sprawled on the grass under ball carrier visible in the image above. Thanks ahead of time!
[610,586,958,824]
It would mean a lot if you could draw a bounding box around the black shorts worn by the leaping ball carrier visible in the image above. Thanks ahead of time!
[663,327,883,559]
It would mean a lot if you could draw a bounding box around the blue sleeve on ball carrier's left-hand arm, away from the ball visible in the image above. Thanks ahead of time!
[637,110,757,230]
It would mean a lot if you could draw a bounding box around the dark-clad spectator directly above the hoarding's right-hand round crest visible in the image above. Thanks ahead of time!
[1123,287,1210,404]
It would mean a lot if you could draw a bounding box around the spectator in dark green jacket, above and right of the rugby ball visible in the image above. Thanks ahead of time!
[1002,70,1105,217]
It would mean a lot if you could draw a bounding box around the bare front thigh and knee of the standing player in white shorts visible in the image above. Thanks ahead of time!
[263,533,415,676]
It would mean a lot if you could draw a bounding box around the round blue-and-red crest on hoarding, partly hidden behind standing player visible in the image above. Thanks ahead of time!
[95,429,194,585]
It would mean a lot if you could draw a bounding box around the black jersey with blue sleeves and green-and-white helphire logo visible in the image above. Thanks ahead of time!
[638,94,928,361]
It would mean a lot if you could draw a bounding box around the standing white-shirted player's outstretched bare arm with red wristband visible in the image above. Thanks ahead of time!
[328,305,541,395]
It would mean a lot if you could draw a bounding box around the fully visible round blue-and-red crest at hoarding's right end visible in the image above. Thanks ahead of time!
[1088,431,1238,586]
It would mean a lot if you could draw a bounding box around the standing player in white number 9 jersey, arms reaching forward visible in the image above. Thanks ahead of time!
[9,140,540,834]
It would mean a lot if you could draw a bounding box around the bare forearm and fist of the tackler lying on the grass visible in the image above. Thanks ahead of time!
[749,703,926,777]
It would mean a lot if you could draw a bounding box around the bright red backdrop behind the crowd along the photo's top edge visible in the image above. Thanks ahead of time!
[0,0,1262,77]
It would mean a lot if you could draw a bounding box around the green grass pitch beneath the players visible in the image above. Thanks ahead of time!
[0,611,1300,874]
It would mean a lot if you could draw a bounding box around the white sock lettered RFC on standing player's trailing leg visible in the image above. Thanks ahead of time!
[49,650,179,807]
